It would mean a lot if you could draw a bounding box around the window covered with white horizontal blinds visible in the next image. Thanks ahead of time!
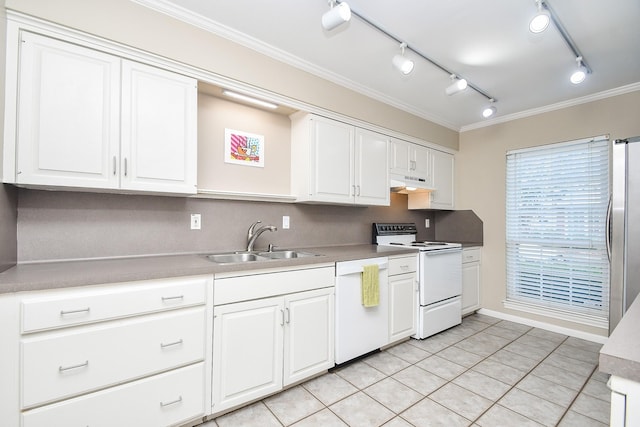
[505,137,609,327]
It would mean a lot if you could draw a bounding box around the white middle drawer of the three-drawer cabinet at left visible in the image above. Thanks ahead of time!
[21,307,205,408]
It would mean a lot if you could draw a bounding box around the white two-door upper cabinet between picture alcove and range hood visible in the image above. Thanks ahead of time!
[291,114,389,206]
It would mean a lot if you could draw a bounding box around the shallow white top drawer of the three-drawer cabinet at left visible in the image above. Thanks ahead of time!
[22,276,211,333]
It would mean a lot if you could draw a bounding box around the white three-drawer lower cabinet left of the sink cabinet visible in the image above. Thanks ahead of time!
[0,276,213,427]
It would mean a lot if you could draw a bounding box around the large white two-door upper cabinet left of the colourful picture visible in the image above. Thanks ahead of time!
[4,31,197,194]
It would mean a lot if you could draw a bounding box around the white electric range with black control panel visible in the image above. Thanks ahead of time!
[372,223,462,339]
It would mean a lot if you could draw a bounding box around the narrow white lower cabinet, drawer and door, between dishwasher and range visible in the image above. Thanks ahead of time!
[389,255,418,343]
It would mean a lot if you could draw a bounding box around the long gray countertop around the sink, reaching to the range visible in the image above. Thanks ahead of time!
[0,245,415,294]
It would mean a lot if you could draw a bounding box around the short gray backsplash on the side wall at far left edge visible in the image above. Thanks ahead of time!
[0,184,18,272]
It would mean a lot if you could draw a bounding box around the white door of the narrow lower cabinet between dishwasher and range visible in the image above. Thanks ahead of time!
[389,273,418,343]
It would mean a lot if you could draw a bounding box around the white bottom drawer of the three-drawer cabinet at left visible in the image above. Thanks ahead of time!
[22,363,205,427]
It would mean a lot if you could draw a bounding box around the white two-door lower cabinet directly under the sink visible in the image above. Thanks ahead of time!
[212,268,334,414]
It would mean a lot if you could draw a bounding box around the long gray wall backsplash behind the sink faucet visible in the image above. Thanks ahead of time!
[17,189,444,262]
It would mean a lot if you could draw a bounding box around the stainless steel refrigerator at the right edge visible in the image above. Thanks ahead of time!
[609,137,640,334]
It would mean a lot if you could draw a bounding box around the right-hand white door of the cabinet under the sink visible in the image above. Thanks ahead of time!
[284,288,335,386]
